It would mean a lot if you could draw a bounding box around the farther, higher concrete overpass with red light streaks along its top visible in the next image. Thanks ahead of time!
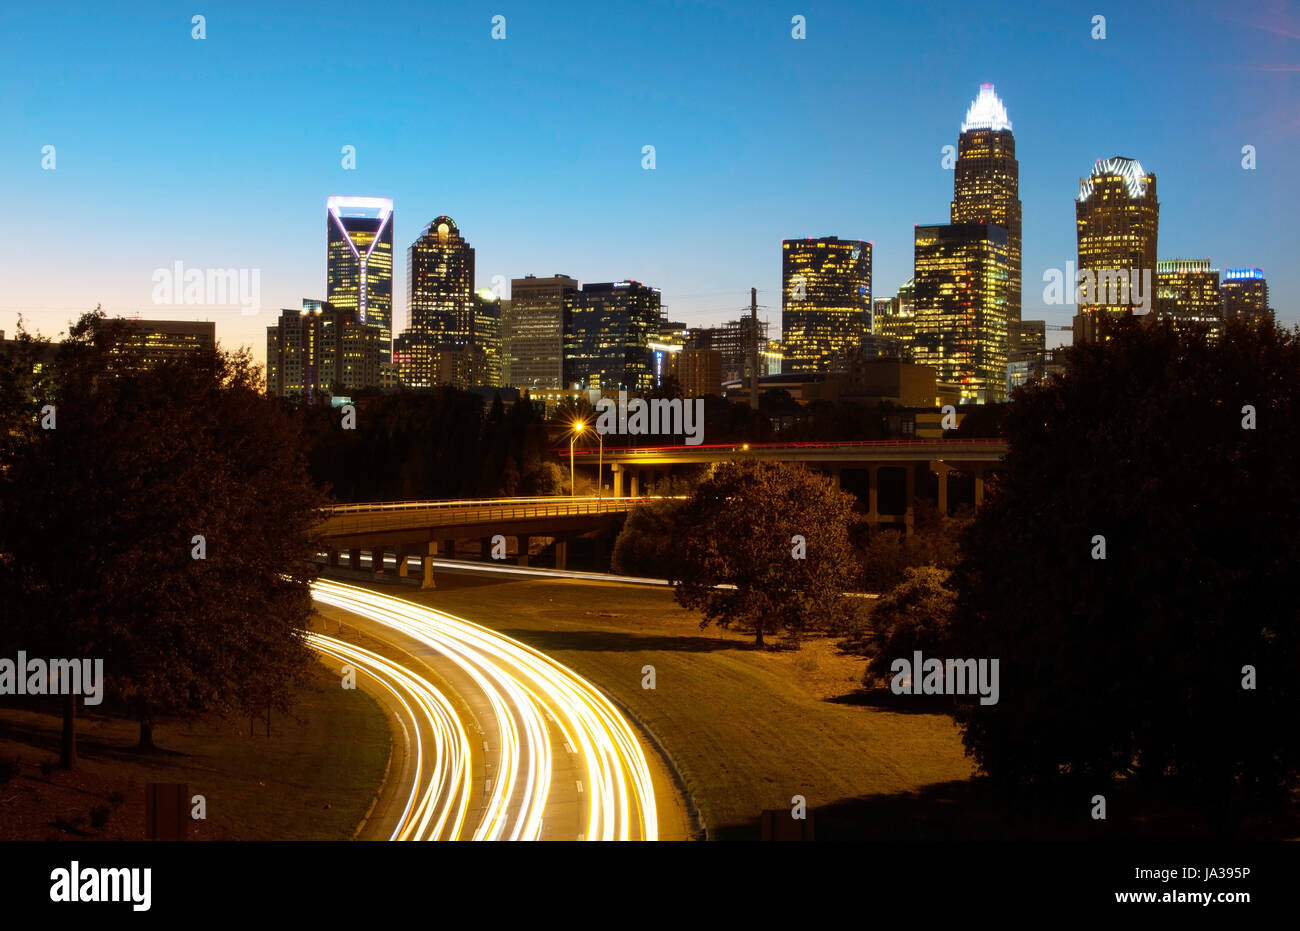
[555,439,1006,533]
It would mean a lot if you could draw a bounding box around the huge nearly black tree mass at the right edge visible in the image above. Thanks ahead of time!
[952,319,1300,811]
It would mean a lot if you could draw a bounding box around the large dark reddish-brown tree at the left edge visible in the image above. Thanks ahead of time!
[0,313,321,765]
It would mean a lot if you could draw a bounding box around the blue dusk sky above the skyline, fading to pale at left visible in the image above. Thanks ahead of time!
[0,0,1300,359]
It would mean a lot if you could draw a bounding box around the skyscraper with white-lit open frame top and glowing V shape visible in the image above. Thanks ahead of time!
[325,196,393,361]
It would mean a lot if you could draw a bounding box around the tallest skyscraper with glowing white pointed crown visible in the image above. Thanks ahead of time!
[950,85,1021,321]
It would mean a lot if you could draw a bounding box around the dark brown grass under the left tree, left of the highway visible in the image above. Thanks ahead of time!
[0,663,389,840]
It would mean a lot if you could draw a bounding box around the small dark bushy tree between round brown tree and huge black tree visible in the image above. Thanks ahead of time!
[863,567,957,685]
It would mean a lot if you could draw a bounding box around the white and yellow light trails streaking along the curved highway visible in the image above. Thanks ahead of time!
[312,580,658,840]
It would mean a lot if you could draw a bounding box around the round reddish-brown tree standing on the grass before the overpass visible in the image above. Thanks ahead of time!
[673,460,857,648]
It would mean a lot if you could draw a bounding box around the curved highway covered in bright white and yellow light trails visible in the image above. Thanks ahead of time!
[308,580,658,840]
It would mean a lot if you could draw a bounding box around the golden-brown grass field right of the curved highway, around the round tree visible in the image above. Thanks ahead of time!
[382,572,972,839]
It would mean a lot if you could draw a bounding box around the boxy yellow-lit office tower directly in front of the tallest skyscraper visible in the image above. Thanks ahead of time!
[911,224,1010,403]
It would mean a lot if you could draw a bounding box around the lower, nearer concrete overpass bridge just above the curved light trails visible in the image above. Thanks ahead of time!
[319,497,642,588]
